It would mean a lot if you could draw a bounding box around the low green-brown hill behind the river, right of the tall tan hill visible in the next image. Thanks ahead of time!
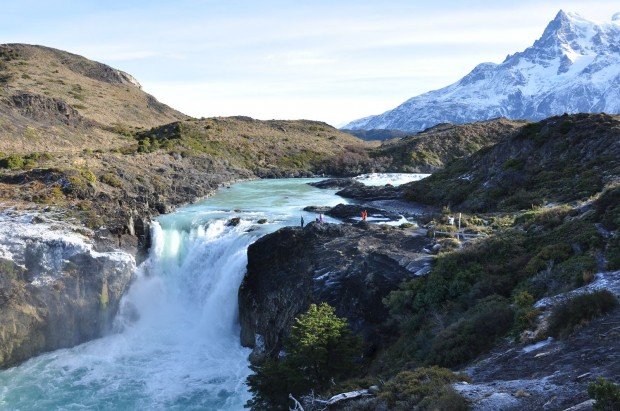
[135,117,378,176]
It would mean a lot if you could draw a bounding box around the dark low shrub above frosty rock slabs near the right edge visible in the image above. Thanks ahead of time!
[549,290,618,338]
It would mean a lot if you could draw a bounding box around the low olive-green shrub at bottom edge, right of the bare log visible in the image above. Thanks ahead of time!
[379,367,469,411]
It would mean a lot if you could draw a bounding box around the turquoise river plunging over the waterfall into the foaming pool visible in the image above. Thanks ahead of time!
[0,179,343,410]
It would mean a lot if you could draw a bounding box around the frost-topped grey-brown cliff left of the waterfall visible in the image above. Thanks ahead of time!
[0,211,135,367]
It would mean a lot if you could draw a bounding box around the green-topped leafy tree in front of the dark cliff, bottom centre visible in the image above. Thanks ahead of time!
[247,303,360,410]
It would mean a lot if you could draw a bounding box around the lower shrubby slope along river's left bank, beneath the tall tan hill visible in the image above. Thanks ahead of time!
[0,117,378,237]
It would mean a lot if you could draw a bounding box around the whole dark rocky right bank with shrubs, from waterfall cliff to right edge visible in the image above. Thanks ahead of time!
[239,172,620,410]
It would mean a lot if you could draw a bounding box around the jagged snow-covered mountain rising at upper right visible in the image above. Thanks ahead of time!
[343,10,620,132]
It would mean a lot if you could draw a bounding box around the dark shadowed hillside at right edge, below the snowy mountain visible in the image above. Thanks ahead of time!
[404,114,620,212]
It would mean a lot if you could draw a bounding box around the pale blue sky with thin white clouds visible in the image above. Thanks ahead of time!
[0,0,620,125]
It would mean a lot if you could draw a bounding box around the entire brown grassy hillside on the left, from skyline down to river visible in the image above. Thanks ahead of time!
[0,44,381,236]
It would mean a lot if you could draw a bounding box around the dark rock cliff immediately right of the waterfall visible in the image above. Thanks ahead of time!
[239,223,430,362]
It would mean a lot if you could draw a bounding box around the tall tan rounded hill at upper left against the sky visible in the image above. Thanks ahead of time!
[0,44,187,152]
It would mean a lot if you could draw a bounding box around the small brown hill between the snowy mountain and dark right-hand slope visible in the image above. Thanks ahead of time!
[373,118,527,173]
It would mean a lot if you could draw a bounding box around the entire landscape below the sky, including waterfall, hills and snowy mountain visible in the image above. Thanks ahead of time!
[0,7,620,411]
